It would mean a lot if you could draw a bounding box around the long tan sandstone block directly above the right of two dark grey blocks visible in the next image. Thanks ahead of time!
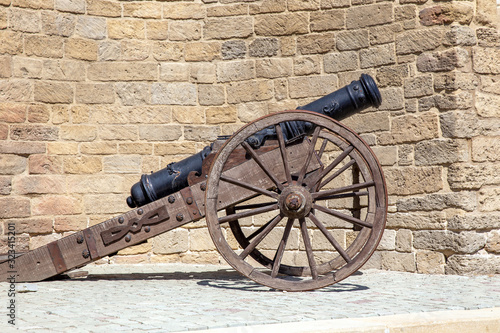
[254,13,309,36]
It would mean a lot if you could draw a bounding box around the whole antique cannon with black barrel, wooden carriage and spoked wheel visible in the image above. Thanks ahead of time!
[0,74,388,291]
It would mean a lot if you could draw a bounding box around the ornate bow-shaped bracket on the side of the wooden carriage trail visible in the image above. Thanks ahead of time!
[101,206,170,245]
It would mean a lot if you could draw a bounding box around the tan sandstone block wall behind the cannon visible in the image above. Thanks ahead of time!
[0,0,500,274]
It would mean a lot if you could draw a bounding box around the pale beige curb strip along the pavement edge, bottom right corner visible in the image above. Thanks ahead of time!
[190,308,500,333]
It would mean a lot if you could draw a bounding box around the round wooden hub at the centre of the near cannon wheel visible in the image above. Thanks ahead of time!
[278,185,312,218]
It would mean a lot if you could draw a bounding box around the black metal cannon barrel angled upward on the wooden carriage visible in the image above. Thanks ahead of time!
[127,74,382,208]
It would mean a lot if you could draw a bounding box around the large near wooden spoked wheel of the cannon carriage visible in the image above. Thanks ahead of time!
[206,110,387,291]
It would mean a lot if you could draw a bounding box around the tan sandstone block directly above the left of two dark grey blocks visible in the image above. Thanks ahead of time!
[203,16,253,39]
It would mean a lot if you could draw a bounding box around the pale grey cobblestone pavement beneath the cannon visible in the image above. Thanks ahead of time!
[0,264,500,332]
